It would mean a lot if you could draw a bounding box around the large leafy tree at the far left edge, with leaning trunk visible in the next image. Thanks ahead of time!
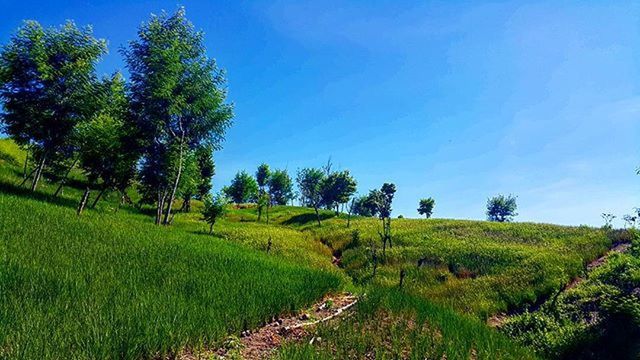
[0,21,107,190]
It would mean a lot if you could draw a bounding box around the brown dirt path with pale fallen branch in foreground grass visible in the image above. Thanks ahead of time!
[178,293,358,360]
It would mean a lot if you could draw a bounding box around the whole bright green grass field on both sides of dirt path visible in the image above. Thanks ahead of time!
[0,139,610,359]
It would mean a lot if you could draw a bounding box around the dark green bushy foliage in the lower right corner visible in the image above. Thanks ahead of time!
[501,231,640,359]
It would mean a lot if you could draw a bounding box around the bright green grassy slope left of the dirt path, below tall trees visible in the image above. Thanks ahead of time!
[0,142,344,359]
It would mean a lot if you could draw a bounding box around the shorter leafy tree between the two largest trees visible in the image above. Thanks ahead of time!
[73,73,139,214]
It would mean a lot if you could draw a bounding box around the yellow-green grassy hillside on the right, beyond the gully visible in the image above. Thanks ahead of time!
[231,207,611,319]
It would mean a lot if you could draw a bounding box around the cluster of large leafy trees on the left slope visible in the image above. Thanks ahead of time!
[0,9,233,224]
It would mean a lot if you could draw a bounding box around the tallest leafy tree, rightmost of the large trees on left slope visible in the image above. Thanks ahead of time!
[123,8,233,224]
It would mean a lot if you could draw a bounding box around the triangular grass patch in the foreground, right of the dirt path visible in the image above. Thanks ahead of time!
[278,288,536,360]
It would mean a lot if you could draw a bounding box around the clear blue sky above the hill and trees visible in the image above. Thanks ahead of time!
[0,0,640,225]
